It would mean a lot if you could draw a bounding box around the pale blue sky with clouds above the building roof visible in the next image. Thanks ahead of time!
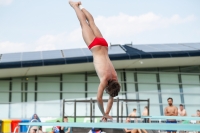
[0,0,200,53]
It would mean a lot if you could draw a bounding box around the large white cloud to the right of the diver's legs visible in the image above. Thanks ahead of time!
[95,12,195,38]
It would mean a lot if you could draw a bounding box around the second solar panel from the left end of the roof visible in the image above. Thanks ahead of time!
[22,52,42,61]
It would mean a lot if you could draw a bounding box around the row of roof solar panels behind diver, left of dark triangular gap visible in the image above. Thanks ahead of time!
[0,45,126,63]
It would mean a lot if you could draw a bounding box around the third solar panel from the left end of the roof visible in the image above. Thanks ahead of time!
[42,50,63,59]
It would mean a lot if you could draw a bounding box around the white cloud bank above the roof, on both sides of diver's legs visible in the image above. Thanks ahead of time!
[0,12,195,53]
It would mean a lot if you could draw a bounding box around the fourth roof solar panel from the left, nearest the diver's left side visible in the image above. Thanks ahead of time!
[63,48,86,57]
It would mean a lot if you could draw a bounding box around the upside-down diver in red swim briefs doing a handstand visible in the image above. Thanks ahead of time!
[69,0,120,121]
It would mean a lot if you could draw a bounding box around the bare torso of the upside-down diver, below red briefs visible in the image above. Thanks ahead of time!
[91,46,117,81]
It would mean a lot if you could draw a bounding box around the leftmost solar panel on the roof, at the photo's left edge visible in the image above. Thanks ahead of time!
[1,53,21,62]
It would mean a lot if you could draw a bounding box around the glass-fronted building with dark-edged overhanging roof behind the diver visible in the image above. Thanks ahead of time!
[0,44,200,119]
